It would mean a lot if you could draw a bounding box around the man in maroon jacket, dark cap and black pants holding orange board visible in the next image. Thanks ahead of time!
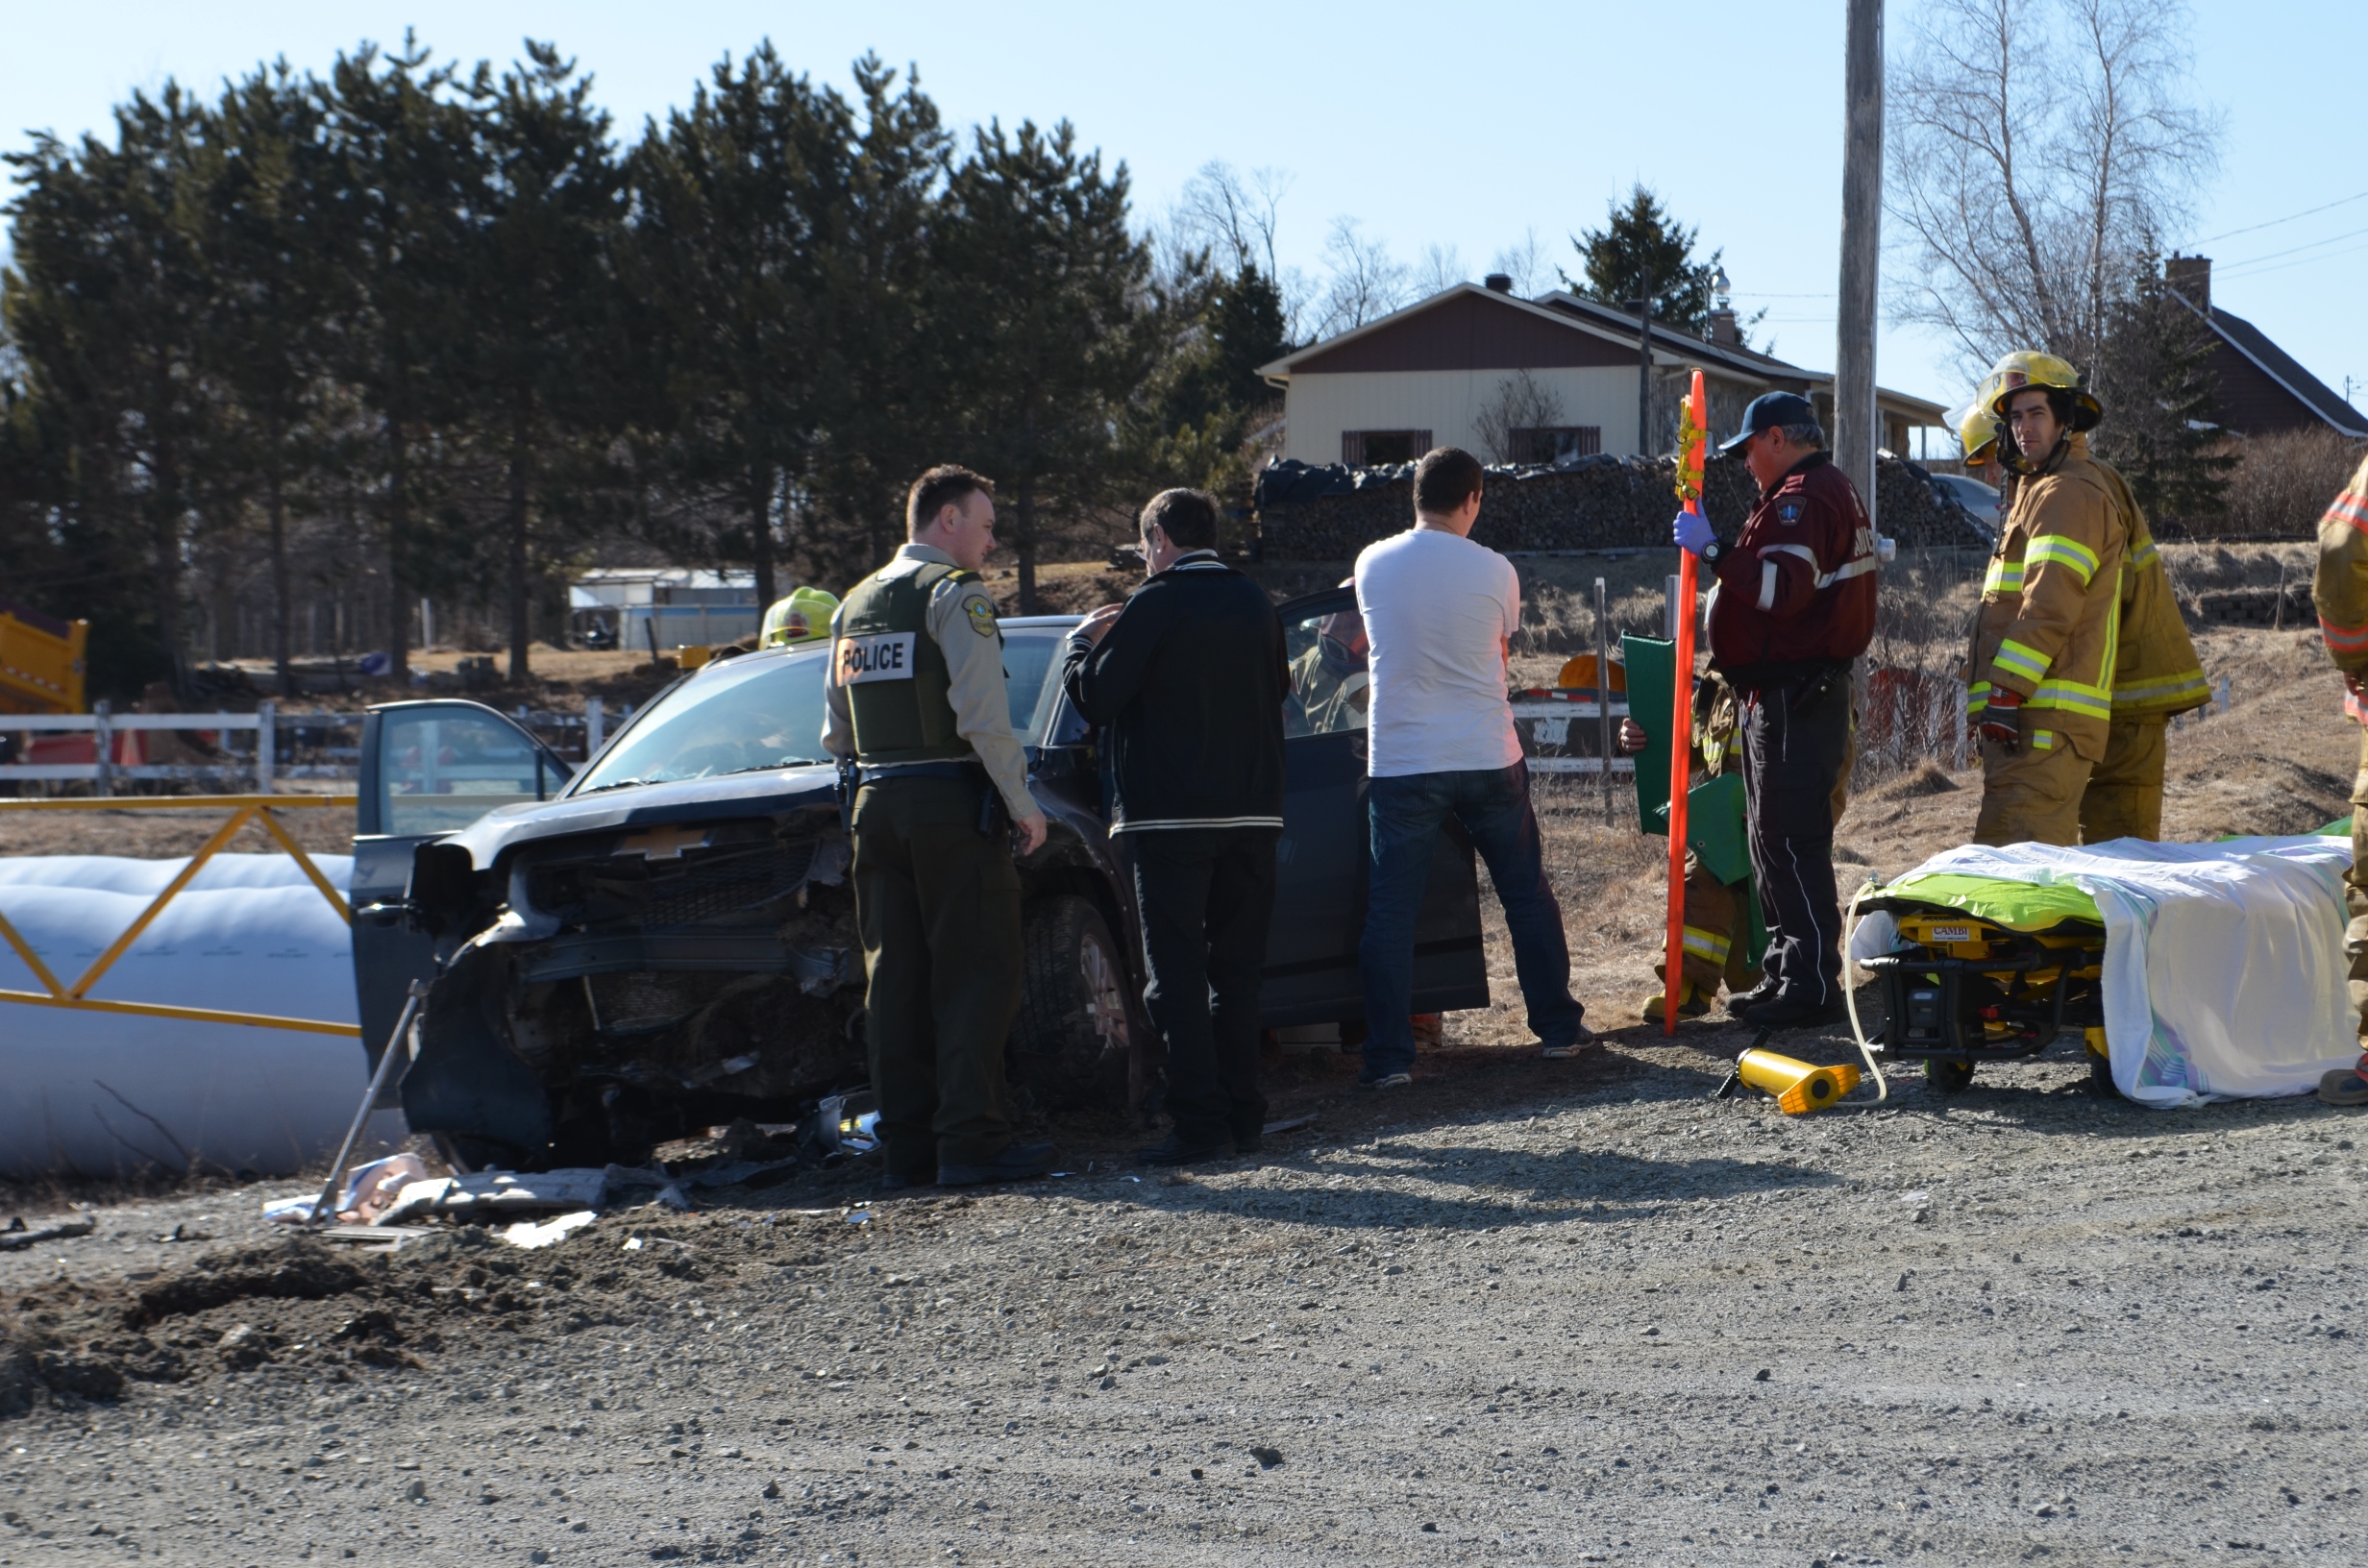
[1672,393,1875,1028]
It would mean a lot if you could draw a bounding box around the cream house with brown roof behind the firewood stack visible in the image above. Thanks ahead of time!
[1260,273,1946,467]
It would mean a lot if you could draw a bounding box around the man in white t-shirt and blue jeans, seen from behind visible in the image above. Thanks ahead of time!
[1357,448,1593,1090]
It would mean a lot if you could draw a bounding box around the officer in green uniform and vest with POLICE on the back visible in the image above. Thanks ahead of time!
[822,464,1053,1187]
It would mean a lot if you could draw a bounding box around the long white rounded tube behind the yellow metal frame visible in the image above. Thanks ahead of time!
[0,855,405,1177]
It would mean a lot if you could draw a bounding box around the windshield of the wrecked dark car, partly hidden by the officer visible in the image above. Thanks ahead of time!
[568,625,1068,796]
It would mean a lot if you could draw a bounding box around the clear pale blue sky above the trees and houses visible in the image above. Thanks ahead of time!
[0,0,2368,445]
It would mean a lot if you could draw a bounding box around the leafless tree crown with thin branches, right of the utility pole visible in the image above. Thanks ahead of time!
[1887,0,2221,375]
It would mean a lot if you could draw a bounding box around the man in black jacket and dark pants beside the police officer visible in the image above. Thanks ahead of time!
[1063,490,1291,1165]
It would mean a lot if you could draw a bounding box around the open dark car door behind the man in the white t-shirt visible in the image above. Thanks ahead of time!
[1262,587,1487,1028]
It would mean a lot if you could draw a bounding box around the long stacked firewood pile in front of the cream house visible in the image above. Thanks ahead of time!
[1255,454,1989,561]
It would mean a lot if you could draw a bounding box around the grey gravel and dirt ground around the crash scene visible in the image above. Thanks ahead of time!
[0,630,2368,1568]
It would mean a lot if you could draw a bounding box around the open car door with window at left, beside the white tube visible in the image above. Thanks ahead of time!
[353,701,568,1094]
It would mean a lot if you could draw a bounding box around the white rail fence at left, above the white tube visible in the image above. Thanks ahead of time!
[0,697,632,796]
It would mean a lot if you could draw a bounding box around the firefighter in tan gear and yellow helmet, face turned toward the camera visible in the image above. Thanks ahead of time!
[1968,353,2129,844]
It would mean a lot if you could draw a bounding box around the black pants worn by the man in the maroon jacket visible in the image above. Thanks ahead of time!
[1743,668,1849,1004]
